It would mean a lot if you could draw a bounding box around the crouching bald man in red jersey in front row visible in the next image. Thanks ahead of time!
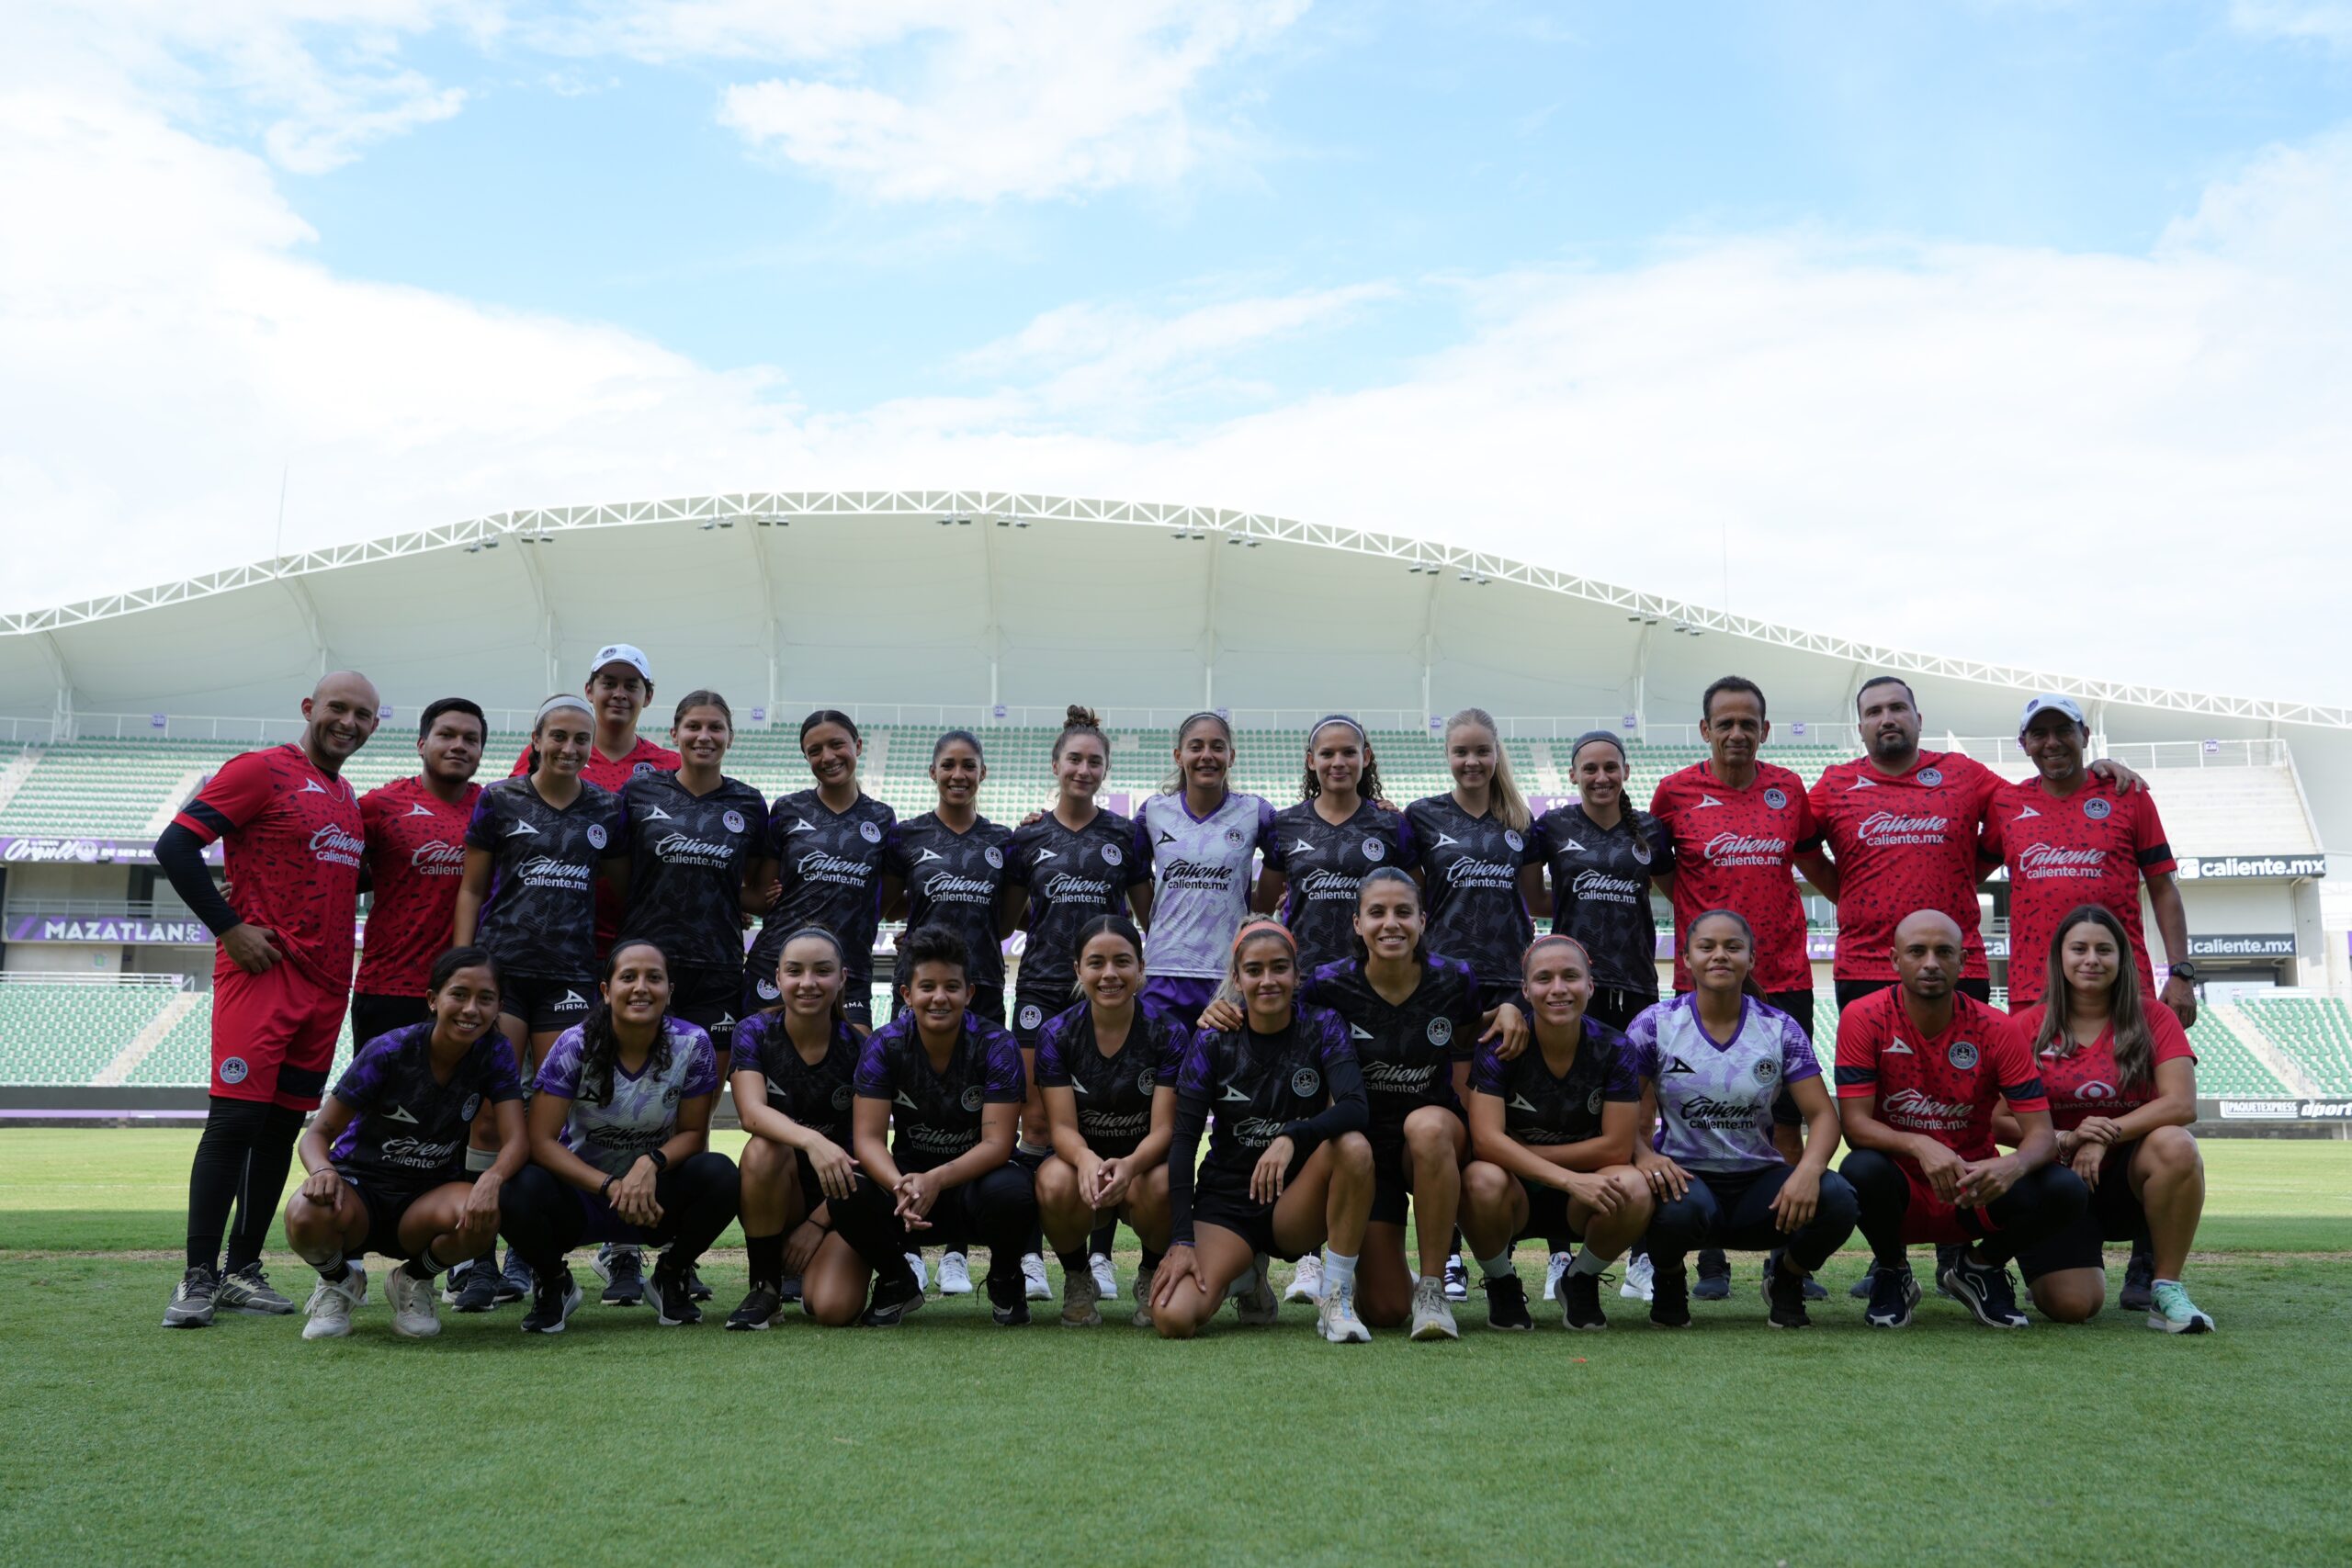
[1837,909,2091,1328]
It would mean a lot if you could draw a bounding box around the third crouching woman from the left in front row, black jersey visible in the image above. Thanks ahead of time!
[727,926,864,1331]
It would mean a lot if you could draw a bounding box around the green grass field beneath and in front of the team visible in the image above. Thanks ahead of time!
[0,1131,2352,1568]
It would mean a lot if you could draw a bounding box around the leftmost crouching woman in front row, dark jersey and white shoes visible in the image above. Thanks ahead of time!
[287,947,529,1340]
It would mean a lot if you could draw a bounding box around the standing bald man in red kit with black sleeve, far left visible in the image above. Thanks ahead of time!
[155,670,379,1328]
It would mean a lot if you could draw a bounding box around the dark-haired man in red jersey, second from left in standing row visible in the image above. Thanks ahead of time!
[350,696,489,1042]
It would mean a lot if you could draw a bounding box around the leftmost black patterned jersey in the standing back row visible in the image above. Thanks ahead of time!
[466,776,628,980]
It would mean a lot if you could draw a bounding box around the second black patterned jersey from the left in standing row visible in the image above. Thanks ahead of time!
[621,769,767,971]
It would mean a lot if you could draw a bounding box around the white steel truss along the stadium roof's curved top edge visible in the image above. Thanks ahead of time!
[0,489,2352,728]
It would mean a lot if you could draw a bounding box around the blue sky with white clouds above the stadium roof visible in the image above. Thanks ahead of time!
[0,0,2352,698]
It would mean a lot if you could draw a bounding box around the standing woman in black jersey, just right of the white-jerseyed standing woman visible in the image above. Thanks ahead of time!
[1256,712,1419,974]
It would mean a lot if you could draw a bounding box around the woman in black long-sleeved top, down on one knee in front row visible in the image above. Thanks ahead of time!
[1150,919,1371,1345]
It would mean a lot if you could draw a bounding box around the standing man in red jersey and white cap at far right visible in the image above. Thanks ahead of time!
[1983,694,2197,1030]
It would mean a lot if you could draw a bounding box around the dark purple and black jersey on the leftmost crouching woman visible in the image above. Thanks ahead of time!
[327,1022,522,1190]
